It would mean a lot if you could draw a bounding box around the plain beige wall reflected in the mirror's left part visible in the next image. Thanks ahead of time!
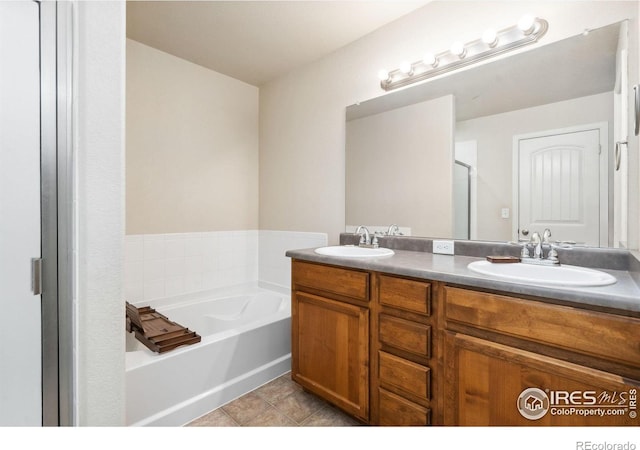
[345,95,455,236]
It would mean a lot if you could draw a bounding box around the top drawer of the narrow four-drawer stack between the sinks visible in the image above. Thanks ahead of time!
[379,275,431,316]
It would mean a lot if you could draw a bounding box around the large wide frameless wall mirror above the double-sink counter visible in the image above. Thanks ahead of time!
[345,21,638,247]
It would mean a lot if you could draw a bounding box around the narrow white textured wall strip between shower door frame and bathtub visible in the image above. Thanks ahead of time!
[73,1,125,426]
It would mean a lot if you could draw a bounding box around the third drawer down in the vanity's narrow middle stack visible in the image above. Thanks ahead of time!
[379,352,431,400]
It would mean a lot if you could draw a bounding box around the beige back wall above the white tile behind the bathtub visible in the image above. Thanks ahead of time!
[126,39,258,234]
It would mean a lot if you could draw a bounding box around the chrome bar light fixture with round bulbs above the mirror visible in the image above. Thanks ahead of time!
[378,15,549,91]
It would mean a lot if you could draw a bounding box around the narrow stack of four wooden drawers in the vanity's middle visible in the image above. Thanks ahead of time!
[371,274,437,426]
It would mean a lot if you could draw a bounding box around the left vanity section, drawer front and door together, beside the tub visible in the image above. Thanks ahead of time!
[291,260,370,422]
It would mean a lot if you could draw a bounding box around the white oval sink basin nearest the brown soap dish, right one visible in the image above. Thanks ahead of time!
[467,261,617,287]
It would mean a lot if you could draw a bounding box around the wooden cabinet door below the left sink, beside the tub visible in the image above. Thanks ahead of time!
[292,292,369,421]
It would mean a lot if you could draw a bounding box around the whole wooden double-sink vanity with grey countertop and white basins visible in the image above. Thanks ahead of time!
[287,234,640,426]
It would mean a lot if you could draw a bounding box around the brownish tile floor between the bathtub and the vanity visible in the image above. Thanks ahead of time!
[186,372,361,427]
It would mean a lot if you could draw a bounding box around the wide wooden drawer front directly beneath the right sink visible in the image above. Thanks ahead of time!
[445,287,640,367]
